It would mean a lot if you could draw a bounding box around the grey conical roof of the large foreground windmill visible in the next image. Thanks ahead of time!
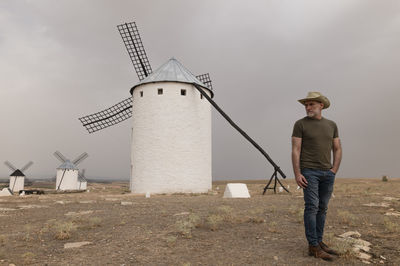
[130,58,213,94]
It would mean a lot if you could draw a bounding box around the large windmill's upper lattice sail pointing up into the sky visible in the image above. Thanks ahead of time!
[117,22,152,80]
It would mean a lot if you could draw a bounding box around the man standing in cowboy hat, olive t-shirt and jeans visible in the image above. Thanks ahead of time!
[292,92,342,260]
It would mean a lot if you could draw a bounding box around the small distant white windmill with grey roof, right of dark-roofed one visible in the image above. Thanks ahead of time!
[54,151,89,190]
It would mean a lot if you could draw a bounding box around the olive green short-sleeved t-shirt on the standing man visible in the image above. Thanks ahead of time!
[292,116,339,170]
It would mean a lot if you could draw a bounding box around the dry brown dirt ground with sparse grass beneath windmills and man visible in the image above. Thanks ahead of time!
[0,179,400,265]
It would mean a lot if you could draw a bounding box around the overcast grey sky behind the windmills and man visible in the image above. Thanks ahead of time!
[0,0,400,180]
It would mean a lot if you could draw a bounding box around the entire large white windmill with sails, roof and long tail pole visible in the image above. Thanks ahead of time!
[79,22,286,193]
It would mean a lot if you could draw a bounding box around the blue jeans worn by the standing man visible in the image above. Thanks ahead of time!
[301,168,335,246]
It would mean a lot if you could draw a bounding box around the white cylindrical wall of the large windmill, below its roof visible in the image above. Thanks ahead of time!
[130,82,212,193]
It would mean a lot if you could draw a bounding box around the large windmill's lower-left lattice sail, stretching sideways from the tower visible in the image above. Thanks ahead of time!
[79,97,132,133]
